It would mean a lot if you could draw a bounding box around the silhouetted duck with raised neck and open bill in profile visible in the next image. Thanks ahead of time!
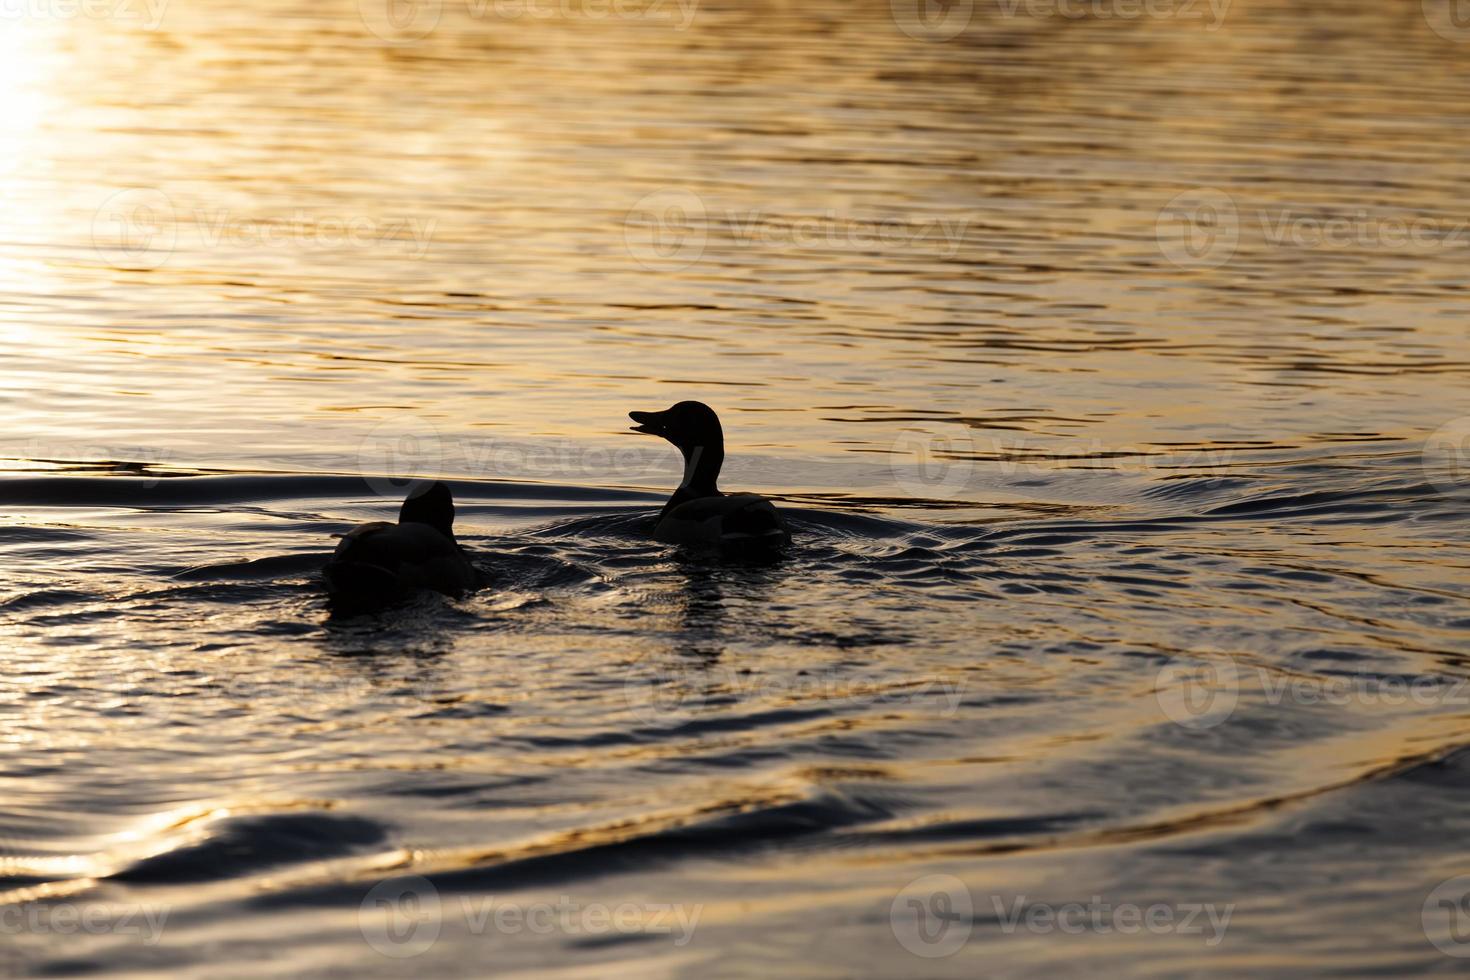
[628,401,791,551]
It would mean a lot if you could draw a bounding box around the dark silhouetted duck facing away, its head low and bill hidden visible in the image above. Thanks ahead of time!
[322,480,481,608]
